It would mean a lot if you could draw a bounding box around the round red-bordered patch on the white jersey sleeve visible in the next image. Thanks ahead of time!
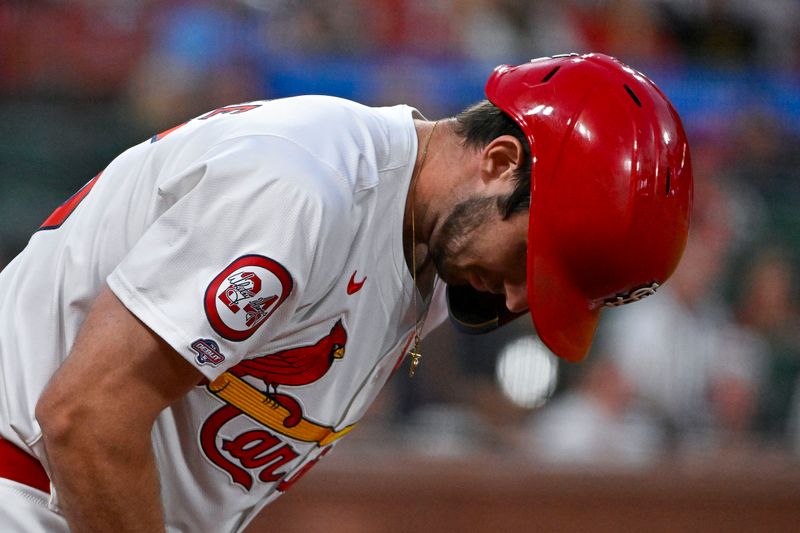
[203,255,293,341]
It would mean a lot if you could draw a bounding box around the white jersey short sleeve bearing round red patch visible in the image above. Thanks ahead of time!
[107,136,346,380]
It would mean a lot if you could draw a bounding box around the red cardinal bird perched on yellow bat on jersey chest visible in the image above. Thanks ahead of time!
[229,320,347,428]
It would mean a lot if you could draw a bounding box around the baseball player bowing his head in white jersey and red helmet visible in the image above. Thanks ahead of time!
[0,54,692,532]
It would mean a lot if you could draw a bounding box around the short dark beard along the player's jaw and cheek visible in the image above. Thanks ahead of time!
[429,197,498,285]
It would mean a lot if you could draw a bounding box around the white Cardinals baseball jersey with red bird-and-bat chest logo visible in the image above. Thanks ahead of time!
[0,97,441,532]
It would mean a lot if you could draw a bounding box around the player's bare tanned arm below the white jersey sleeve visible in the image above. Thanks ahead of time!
[36,288,202,532]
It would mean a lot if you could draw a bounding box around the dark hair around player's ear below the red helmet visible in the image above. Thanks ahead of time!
[455,100,531,219]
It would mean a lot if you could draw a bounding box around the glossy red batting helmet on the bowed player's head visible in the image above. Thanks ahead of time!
[451,54,692,361]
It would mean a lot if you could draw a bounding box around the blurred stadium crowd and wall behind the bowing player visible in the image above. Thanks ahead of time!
[0,0,800,532]
